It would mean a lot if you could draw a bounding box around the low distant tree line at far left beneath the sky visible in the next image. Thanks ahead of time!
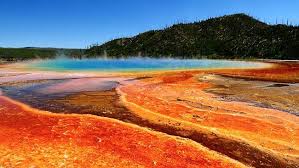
[0,47,85,61]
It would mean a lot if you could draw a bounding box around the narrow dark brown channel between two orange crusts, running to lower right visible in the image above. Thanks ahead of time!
[118,94,298,168]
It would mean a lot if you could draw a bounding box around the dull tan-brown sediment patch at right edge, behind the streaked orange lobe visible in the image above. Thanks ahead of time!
[199,75,299,115]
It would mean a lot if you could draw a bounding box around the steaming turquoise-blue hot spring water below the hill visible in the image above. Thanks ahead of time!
[27,57,265,71]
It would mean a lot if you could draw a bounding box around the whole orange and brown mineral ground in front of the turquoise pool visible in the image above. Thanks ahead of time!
[0,63,299,168]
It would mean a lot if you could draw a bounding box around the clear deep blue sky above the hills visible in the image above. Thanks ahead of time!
[0,0,299,48]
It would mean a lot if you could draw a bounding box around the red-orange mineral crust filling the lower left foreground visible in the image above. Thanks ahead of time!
[0,96,244,167]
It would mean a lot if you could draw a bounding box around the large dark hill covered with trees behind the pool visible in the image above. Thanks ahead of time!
[86,14,299,59]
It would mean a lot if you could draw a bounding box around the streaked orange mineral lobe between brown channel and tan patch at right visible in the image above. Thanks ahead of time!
[119,72,299,167]
